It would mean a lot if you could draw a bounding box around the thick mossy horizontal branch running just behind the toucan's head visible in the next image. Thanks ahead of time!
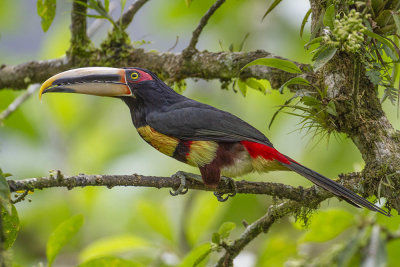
[0,49,304,90]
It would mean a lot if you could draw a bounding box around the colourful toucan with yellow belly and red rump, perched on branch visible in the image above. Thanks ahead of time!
[39,67,390,216]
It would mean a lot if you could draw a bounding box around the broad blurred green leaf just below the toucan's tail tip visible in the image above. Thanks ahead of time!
[296,209,355,242]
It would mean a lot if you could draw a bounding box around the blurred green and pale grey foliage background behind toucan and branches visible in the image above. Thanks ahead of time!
[0,0,400,266]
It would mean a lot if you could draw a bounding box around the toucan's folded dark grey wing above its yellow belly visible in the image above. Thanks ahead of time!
[146,100,272,147]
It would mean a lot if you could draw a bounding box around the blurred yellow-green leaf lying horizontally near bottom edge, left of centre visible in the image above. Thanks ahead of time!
[79,235,149,262]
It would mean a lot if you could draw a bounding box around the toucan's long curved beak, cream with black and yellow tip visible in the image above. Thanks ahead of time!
[39,67,132,99]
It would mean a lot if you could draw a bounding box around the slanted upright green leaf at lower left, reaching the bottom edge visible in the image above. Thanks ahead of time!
[46,214,83,266]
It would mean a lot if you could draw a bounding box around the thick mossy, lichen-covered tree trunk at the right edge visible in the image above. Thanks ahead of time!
[304,0,400,214]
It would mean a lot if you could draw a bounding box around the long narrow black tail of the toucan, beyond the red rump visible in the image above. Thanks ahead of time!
[282,159,391,217]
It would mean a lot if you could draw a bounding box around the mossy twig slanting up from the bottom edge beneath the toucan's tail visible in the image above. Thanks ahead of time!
[216,201,301,267]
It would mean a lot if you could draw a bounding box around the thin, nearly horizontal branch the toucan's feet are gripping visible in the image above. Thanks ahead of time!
[8,172,332,207]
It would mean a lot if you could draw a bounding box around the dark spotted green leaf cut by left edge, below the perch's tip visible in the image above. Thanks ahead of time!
[1,205,19,250]
